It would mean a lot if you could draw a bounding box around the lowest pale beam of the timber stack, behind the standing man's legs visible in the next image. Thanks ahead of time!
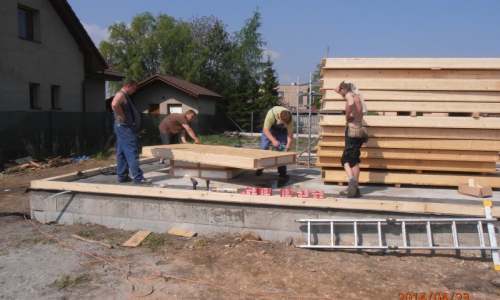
[322,168,500,188]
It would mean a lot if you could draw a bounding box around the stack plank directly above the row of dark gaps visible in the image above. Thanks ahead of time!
[323,100,500,113]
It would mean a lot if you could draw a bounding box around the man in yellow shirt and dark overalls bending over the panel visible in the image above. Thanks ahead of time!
[255,106,293,179]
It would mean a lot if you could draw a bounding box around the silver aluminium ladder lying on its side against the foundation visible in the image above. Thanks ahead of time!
[296,201,500,271]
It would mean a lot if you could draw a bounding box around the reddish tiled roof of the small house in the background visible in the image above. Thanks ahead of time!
[137,74,222,98]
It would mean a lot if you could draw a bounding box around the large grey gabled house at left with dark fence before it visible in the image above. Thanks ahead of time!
[0,0,124,159]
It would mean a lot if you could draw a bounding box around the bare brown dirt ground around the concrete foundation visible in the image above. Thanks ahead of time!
[0,159,500,300]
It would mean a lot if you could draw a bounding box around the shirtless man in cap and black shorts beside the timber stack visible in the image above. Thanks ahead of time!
[335,81,366,198]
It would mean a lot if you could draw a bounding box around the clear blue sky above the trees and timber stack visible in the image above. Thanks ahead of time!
[68,0,500,84]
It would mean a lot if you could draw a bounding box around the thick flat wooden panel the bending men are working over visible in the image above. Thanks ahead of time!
[142,144,297,169]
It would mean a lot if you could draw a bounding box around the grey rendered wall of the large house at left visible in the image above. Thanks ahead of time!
[0,0,88,112]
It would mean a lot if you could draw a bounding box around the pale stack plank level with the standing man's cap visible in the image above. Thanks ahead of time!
[320,77,500,91]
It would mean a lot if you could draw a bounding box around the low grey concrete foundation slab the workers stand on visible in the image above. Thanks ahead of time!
[30,162,498,251]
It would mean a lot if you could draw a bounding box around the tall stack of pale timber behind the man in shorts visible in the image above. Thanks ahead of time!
[317,58,500,188]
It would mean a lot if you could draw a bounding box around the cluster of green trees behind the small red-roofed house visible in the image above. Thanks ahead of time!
[99,11,265,129]
